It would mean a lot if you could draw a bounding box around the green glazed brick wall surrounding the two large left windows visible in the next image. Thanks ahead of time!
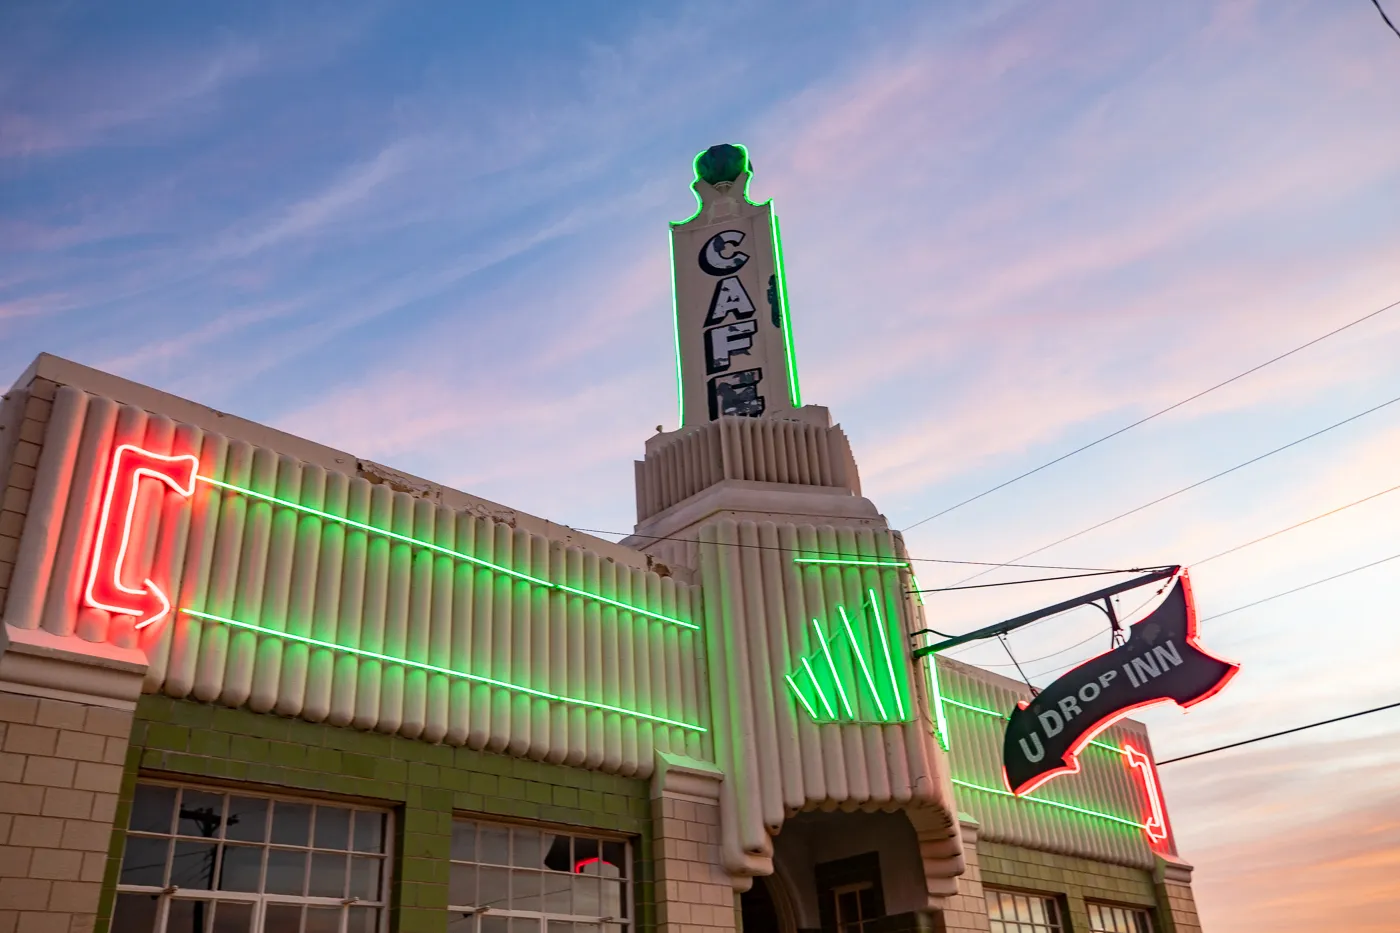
[95,696,655,933]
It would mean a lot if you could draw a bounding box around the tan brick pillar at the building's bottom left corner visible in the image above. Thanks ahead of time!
[0,692,132,933]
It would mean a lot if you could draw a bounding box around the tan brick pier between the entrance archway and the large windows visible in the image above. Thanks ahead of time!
[651,794,736,933]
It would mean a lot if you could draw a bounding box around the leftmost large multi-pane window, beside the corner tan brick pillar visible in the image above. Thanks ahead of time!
[112,782,388,933]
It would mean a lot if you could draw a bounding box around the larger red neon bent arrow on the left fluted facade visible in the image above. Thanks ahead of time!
[84,444,199,629]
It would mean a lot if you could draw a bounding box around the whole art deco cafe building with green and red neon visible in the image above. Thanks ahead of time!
[0,147,1198,933]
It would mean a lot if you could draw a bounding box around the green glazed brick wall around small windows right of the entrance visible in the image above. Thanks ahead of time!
[977,842,1162,930]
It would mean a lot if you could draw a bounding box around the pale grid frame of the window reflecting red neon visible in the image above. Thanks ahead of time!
[447,813,638,933]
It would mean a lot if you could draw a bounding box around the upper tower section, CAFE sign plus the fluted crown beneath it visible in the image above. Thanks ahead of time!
[624,144,889,566]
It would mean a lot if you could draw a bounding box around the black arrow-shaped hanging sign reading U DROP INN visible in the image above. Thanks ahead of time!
[1001,570,1239,794]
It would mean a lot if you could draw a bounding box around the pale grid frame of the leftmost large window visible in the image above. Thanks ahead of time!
[112,776,396,933]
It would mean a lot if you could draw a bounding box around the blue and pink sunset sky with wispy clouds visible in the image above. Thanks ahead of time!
[0,0,1400,933]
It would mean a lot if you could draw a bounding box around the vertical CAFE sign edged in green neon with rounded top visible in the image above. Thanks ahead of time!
[671,146,802,426]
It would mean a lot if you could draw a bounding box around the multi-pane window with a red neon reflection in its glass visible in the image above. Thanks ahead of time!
[448,820,631,933]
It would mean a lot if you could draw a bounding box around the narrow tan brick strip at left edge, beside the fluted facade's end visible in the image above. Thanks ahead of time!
[0,380,57,613]
